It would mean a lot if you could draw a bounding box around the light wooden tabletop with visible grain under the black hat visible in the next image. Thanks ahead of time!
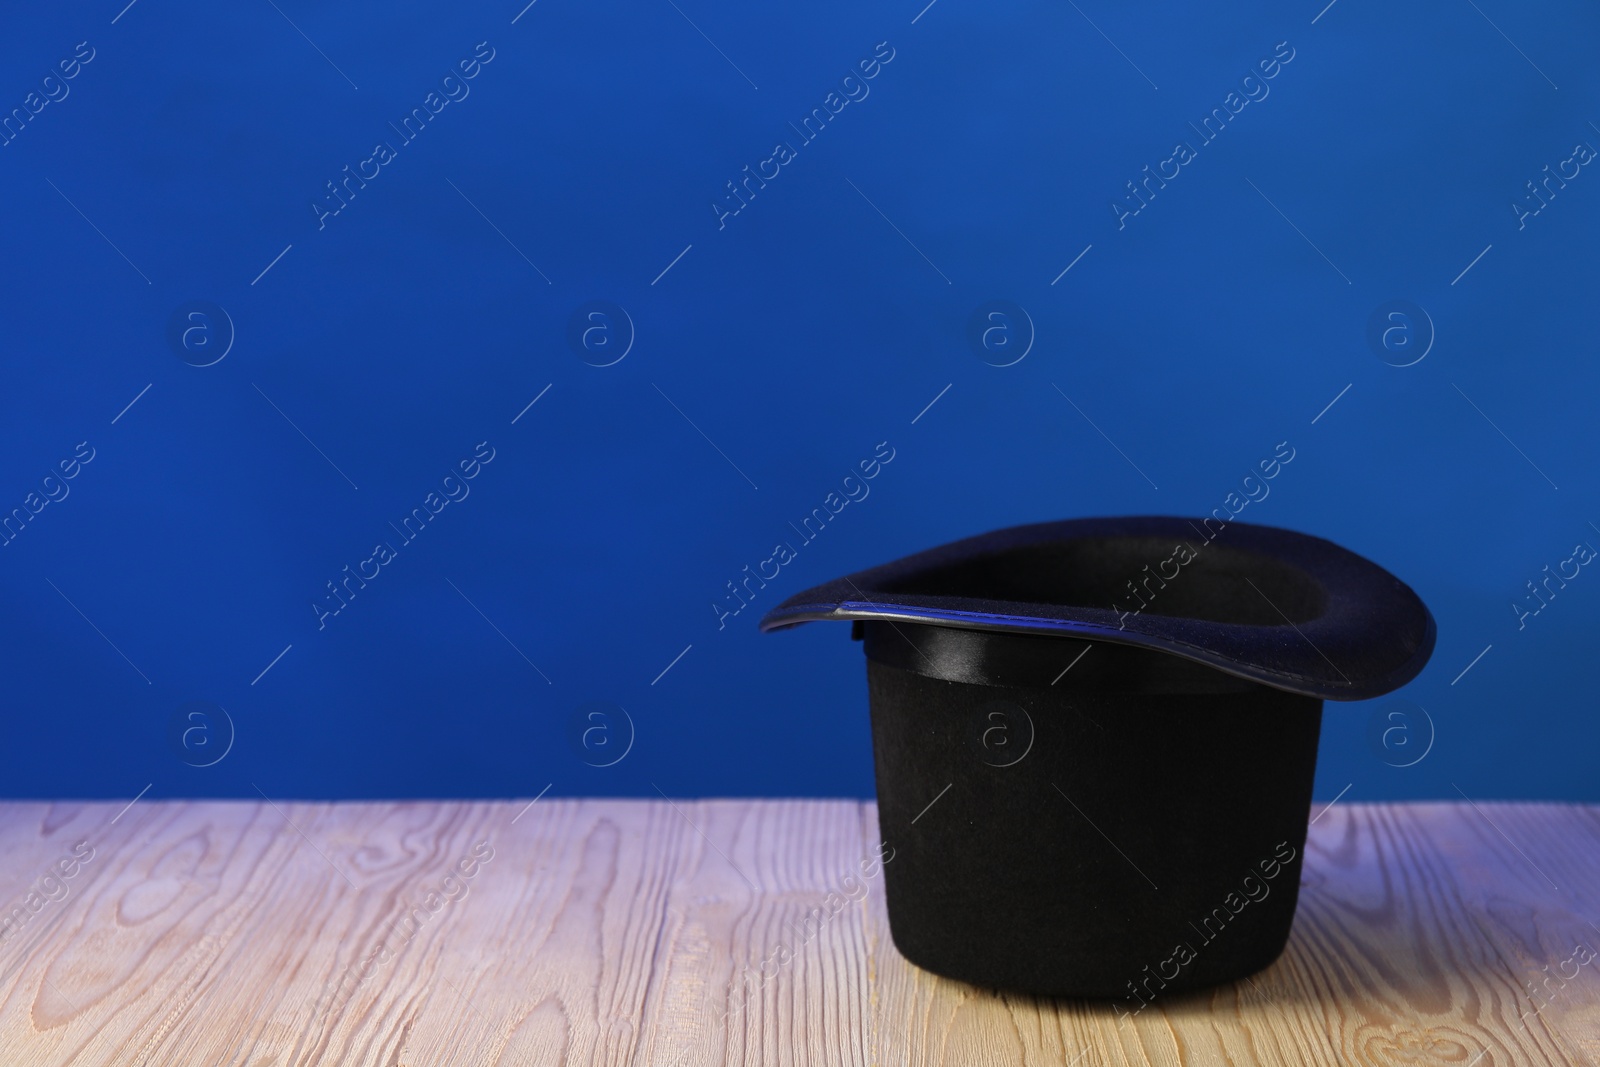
[0,798,1600,1067]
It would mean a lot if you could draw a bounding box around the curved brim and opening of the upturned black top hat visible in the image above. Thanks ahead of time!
[760,515,1435,701]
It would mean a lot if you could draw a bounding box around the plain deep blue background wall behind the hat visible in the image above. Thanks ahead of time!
[0,0,1600,800]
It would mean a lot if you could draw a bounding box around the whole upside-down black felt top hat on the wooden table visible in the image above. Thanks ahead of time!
[762,517,1434,1014]
